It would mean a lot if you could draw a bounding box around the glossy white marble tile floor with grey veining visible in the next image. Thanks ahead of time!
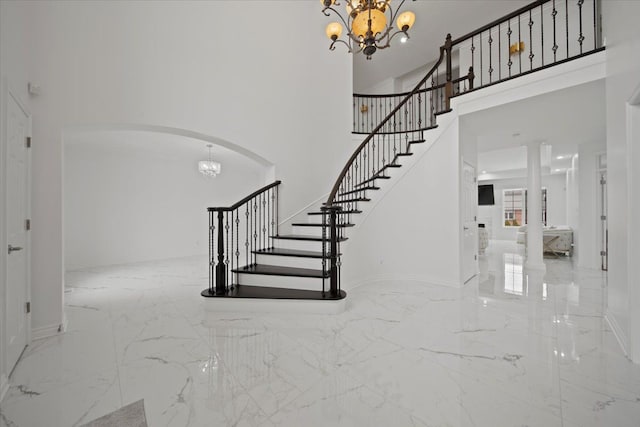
[0,242,640,427]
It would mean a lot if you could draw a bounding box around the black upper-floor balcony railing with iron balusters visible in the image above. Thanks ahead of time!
[353,0,603,134]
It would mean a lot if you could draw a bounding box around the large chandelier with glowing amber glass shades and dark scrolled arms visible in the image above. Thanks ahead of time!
[320,0,416,59]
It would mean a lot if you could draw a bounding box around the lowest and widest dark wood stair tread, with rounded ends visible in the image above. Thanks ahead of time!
[200,285,347,301]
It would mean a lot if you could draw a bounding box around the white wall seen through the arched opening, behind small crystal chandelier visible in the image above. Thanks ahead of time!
[64,132,266,270]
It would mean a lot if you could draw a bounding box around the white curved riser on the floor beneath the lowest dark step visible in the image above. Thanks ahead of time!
[203,298,347,316]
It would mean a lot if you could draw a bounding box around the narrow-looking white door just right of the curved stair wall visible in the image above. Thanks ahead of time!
[462,163,478,282]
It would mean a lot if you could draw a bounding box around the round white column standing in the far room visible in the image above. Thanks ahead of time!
[525,141,546,270]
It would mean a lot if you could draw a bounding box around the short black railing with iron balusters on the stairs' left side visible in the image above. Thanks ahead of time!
[203,181,281,296]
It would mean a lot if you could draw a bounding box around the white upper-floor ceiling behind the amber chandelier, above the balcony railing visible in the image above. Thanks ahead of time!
[352,0,530,92]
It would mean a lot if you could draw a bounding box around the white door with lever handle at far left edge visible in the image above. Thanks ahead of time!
[3,93,30,372]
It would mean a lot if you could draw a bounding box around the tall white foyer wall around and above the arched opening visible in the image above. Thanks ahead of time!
[16,1,352,338]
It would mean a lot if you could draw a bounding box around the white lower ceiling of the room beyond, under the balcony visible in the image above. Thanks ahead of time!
[460,80,606,177]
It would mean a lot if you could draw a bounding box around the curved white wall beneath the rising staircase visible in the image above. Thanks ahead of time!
[342,112,461,286]
